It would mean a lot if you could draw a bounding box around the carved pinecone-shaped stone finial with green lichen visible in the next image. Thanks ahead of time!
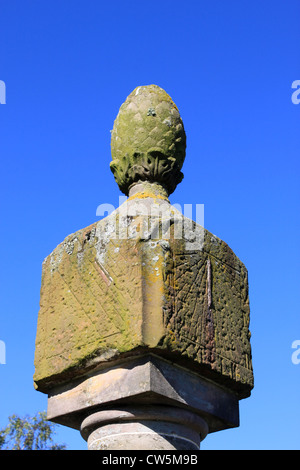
[110,85,186,195]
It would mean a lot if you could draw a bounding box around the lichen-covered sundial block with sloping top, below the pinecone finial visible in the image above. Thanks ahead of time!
[34,186,253,398]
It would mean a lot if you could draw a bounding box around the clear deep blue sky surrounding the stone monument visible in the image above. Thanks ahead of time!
[0,0,300,449]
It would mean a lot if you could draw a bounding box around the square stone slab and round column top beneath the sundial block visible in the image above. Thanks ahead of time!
[47,354,239,451]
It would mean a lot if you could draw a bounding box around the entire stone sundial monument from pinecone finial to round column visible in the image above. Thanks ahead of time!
[34,85,253,450]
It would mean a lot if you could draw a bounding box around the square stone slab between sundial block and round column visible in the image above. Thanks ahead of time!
[47,353,239,432]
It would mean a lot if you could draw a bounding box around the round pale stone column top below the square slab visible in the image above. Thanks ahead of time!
[81,406,208,450]
